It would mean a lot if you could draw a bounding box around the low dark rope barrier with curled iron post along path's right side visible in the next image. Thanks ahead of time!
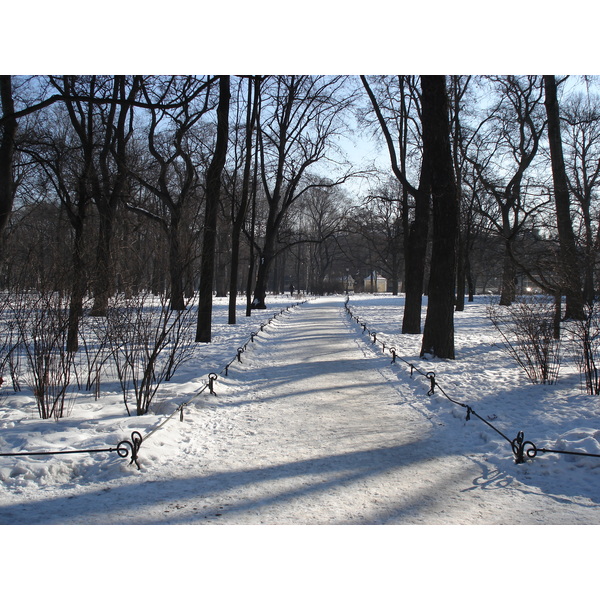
[344,297,600,464]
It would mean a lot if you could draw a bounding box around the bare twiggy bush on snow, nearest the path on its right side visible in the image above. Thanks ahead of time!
[488,296,561,384]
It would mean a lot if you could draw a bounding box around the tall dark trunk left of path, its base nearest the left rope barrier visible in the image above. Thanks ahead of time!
[196,75,231,343]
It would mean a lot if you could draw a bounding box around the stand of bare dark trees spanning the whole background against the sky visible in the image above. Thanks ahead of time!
[0,75,600,358]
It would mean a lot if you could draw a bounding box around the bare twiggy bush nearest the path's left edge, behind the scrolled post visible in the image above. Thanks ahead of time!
[106,294,193,415]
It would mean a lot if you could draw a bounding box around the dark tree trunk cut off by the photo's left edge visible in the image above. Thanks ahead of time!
[0,75,17,239]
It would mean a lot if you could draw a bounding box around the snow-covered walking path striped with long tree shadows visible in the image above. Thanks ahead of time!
[0,298,600,524]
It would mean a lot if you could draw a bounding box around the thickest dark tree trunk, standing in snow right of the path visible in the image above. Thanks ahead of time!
[421,75,458,358]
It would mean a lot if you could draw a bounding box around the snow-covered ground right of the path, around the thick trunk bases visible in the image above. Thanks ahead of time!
[350,296,600,508]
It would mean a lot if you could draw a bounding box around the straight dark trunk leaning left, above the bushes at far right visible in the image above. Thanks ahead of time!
[544,75,585,319]
